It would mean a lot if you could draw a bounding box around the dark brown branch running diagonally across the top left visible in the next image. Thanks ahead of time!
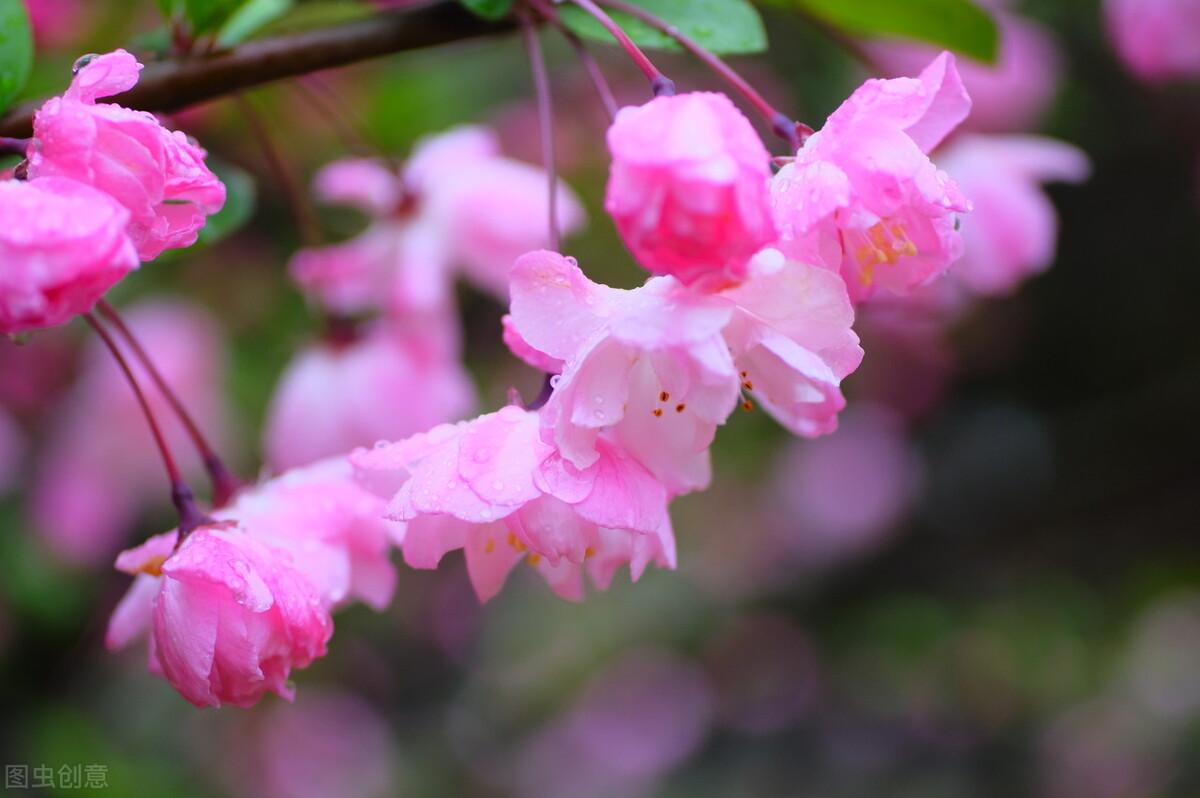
[0,1,514,137]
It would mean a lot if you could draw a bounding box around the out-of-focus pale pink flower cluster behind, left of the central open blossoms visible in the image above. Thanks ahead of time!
[265,127,583,469]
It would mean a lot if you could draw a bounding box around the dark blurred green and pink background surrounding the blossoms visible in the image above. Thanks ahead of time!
[0,0,1200,798]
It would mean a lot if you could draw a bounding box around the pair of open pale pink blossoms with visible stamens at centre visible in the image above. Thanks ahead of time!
[506,250,863,493]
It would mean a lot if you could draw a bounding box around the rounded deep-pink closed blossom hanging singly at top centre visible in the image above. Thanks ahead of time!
[605,92,776,288]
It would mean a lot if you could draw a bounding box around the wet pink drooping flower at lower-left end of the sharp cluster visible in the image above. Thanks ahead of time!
[107,523,334,707]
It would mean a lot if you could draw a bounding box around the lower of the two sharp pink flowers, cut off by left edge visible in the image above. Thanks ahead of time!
[0,178,138,334]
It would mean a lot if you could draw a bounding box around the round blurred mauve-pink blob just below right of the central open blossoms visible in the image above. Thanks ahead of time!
[772,403,922,568]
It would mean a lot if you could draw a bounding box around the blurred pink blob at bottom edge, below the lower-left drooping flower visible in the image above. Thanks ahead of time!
[223,691,397,798]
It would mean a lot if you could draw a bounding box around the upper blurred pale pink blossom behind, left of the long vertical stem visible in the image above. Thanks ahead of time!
[290,127,583,317]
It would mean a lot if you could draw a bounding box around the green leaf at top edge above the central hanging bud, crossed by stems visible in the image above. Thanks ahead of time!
[559,0,767,54]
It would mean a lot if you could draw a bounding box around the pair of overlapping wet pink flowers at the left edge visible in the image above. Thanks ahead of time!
[0,50,224,332]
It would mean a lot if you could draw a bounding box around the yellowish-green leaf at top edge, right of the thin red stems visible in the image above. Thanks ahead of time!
[775,0,998,62]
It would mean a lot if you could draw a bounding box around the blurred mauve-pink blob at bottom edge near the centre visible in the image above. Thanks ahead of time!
[517,652,714,798]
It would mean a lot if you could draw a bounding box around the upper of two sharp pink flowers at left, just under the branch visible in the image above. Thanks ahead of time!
[29,49,226,260]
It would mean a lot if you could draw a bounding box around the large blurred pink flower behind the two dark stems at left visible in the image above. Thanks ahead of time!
[30,301,230,564]
